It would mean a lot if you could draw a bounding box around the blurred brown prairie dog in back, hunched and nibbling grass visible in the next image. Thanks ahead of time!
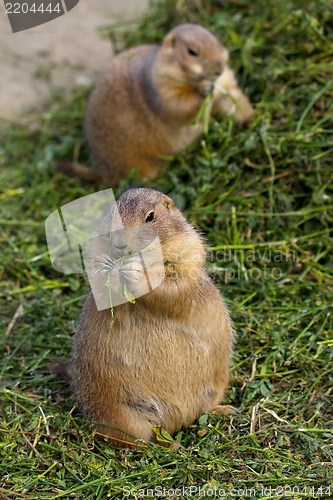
[62,24,253,186]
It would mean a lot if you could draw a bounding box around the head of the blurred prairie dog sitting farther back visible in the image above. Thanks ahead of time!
[155,23,228,94]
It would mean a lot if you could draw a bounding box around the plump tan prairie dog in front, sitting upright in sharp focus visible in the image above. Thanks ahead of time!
[61,188,236,446]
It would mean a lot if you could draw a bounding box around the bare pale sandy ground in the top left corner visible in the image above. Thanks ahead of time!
[0,0,148,120]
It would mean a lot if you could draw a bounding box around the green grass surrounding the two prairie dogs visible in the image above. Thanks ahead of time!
[0,0,333,500]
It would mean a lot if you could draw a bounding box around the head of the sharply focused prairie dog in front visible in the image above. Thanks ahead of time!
[103,188,205,272]
